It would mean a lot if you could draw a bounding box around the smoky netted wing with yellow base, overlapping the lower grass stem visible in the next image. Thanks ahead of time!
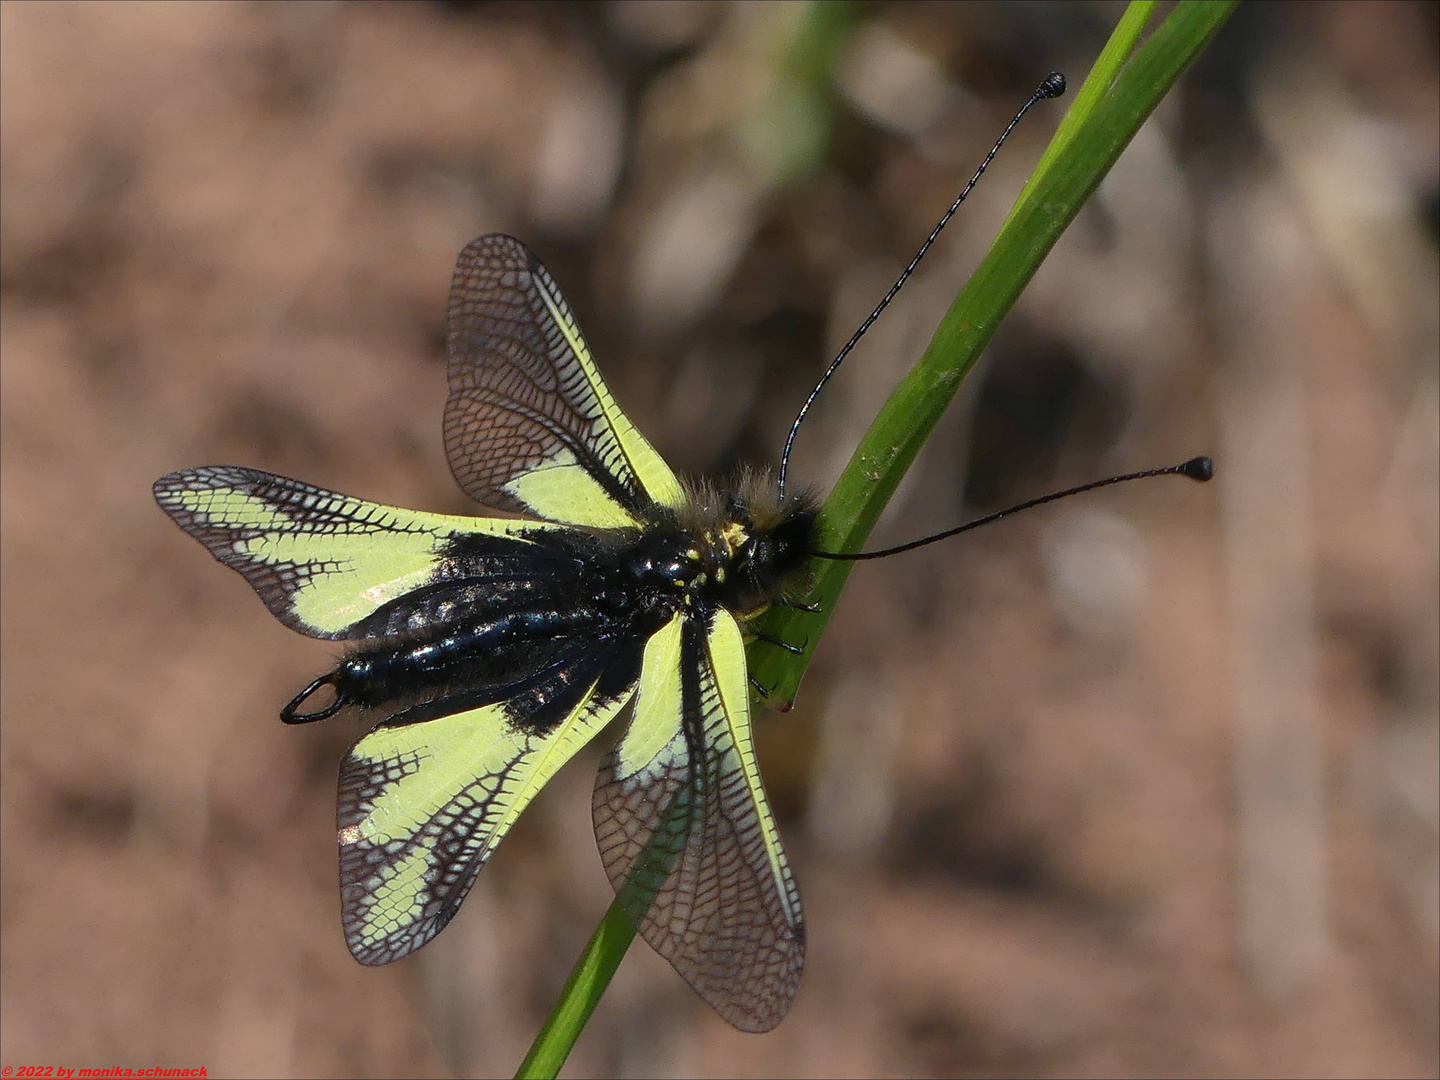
[593,609,805,1031]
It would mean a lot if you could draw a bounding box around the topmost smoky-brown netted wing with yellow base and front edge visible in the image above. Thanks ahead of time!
[445,235,684,528]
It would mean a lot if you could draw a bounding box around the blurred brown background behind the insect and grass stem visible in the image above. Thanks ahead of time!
[0,3,1440,1077]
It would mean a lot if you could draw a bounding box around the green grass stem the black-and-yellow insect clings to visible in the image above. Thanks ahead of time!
[517,0,1236,1077]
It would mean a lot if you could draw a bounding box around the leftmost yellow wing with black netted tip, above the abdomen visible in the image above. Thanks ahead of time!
[154,465,554,638]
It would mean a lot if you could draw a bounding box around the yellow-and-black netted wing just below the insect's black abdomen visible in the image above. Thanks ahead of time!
[337,656,634,963]
